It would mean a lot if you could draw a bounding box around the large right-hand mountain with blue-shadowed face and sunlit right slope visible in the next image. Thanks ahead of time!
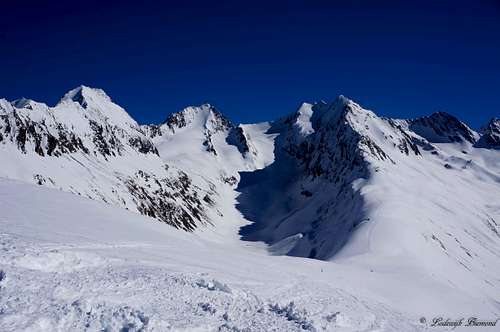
[238,97,500,304]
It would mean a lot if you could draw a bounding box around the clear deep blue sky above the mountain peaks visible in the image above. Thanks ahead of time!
[0,0,500,128]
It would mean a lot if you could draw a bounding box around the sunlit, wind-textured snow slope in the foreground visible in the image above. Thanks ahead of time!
[0,180,499,331]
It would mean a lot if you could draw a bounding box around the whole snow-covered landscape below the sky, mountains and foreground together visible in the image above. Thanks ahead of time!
[0,87,500,331]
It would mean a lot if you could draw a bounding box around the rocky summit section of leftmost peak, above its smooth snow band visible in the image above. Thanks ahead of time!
[0,87,158,158]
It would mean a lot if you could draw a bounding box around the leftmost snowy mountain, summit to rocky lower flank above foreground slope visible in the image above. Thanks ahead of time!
[0,86,215,231]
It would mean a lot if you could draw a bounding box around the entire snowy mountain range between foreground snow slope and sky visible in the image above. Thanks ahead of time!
[0,86,500,325]
